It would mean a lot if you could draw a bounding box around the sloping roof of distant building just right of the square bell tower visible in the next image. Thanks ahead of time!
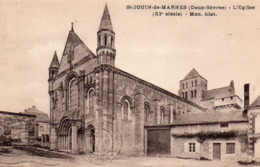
[203,81,236,100]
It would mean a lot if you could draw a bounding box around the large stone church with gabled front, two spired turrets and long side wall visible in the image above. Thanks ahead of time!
[48,6,204,155]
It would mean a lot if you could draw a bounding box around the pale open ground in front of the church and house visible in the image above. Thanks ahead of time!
[0,149,248,167]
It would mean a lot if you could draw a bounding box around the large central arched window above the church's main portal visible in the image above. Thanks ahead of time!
[69,78,78,110]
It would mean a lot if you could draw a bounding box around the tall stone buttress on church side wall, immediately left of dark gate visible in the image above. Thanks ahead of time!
[135,93,144,155]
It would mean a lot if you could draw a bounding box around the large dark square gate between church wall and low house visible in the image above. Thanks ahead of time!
[147,129,171,156]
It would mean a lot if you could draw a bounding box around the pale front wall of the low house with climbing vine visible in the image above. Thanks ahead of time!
[171,122,248,161]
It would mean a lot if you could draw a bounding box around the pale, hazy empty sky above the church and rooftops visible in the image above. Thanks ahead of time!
[0,0,260,113]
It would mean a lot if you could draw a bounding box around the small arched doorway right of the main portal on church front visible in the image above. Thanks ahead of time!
[86,125,95,153]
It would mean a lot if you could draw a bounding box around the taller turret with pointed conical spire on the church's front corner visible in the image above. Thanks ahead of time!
[96,4,116,66]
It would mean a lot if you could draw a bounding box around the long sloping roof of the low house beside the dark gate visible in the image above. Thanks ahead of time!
[173,110,248,125]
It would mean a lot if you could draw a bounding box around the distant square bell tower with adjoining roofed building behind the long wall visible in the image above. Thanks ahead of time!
[179,69,242,111]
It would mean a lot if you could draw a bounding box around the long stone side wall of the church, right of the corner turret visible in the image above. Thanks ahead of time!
[109,65,202,155]
